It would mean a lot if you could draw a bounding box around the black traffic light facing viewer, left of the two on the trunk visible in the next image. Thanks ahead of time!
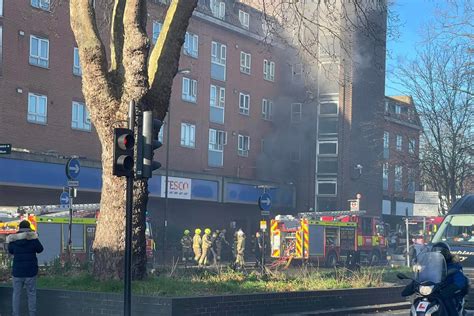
[112,128,135,177]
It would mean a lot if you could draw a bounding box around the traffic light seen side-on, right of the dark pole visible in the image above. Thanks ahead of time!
[142,111,163,178]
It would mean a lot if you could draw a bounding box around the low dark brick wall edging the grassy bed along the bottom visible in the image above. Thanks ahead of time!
[0,287,403,316]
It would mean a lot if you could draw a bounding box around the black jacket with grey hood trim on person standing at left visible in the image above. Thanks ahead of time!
[7,230,43,278]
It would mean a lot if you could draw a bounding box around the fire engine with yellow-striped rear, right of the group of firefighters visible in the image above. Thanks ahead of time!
[270,211,387,266]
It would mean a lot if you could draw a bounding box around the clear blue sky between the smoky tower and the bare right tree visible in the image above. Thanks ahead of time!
[385,0,446,96]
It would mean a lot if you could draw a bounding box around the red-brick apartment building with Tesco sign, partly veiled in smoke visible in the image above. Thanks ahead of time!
[0,0,418,235]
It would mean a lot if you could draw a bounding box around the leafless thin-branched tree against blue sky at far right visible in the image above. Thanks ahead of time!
[398,36,474,208]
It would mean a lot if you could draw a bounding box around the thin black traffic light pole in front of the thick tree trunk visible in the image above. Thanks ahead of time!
[123,101,135,316]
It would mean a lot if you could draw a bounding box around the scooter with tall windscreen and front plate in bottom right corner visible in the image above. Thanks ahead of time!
[397,252,465,316]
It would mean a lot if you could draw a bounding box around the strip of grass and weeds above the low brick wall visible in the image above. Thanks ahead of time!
[0,268,407,297]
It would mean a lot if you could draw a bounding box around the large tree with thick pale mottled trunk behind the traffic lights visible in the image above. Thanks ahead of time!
[70,0,198,279]
